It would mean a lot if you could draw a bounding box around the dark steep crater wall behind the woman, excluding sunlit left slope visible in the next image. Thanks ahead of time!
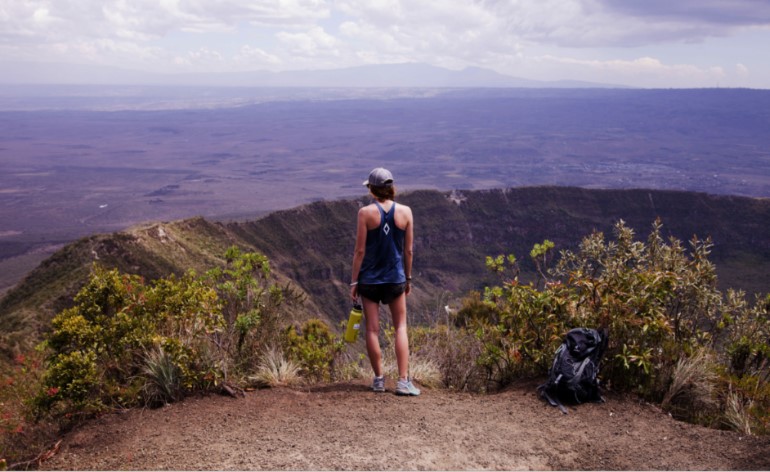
[236,187,770,319]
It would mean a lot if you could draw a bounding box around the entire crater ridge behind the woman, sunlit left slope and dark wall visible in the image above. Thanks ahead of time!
[0,187,770,355]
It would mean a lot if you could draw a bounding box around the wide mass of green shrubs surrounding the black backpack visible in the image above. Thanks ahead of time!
[459,221,720,400]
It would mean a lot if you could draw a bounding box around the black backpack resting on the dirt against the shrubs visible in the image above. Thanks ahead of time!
[537,328,607,414]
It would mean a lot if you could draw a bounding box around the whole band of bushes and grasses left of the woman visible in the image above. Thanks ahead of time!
[0,246,318,466]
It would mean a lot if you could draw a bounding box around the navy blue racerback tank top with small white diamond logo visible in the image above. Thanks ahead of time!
[358,202,406,284]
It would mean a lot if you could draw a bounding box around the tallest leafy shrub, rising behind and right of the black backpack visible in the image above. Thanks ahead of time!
[554,221,721,400]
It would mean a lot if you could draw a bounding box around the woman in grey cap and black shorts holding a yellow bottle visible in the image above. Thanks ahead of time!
[350,167,420,396]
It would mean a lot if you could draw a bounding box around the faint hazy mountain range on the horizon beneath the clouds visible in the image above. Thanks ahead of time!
[0,62,625,88]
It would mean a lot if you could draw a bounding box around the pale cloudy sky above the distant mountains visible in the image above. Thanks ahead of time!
[0,0,770,88]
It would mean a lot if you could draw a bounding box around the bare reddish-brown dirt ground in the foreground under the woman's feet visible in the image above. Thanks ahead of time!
[42,381,770,470]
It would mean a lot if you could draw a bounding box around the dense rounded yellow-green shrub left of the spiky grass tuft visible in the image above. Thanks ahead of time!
[36,265,221,414]
